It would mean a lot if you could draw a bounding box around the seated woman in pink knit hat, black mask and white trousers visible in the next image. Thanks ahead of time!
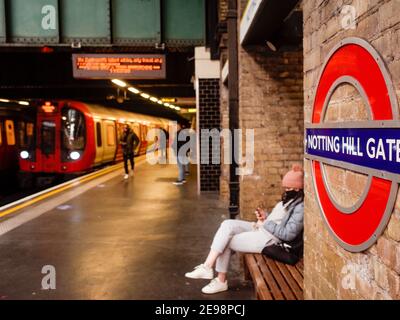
[185,165,304,294]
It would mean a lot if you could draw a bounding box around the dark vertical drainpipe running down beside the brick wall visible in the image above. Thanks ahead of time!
[227,0,239,219]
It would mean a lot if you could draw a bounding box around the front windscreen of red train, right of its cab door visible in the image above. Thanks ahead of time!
[61,108,86,151]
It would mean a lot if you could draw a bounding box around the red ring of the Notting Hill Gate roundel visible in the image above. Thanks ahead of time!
[312,39,395,251]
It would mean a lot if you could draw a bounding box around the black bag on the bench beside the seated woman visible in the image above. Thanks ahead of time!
[262,232,304,265]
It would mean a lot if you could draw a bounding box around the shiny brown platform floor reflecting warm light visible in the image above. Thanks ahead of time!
[0,163,254,300]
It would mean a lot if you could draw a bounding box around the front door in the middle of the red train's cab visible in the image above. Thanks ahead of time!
[37,115,60,172]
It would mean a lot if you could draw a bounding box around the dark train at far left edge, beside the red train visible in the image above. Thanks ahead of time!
[0,102,35,182]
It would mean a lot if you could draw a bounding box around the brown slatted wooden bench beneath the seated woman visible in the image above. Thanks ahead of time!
[244,253,304,300]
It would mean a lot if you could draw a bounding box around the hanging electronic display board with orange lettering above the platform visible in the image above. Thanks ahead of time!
[72,53,166,80]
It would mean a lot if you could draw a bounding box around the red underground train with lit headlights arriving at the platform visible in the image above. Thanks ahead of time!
[19,101,170,181]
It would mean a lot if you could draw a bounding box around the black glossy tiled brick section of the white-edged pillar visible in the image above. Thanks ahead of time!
[198,79,221,191]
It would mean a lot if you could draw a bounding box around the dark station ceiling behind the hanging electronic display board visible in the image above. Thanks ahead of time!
[0,48,195,118]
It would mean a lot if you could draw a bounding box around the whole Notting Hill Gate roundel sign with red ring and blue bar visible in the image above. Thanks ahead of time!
[305,38,400,252]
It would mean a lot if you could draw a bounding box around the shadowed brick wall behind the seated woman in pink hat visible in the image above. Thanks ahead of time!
[239,1,304,220]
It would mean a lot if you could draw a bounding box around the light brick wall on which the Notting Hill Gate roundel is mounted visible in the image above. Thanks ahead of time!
[303,0,400,299]
